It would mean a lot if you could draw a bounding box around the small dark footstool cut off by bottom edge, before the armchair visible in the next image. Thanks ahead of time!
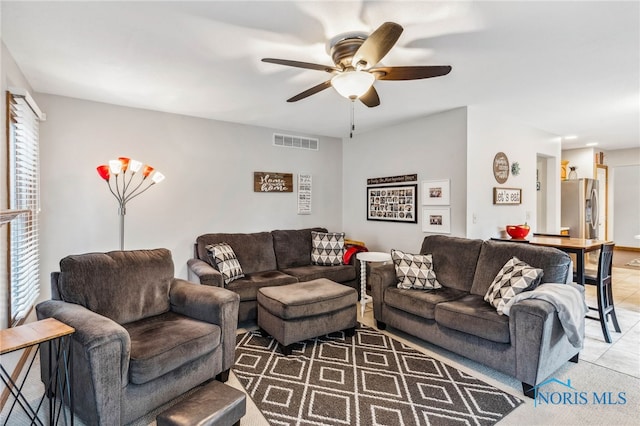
[156,380,247,426]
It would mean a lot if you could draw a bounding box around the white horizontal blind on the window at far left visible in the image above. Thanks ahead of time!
[8,91,43,325]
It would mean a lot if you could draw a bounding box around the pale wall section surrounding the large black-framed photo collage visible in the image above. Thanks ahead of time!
[343,108,467,253]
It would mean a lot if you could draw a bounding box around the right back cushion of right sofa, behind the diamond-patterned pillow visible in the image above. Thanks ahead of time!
[470,240,571,297]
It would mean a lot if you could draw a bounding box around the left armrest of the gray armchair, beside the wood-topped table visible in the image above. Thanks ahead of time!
[36,300,131,424]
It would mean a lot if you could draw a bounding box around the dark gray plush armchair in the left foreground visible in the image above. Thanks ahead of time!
[36,249,239,425]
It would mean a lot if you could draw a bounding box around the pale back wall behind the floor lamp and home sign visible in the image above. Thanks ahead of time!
[38,94,343,298]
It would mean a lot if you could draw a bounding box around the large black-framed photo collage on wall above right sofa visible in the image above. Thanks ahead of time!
[367,184,418,223]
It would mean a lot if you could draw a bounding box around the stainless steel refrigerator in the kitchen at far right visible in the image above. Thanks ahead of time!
[560,179,599,239]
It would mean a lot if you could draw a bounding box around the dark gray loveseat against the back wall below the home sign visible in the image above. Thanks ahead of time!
[187,228,359,322]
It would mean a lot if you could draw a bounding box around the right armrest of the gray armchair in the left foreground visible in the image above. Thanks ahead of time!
[169,278,240,371]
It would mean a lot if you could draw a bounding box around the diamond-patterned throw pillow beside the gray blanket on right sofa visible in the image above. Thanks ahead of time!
[484,256,543,315]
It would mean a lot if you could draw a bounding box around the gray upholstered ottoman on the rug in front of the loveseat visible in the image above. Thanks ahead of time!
[258,278,358,355]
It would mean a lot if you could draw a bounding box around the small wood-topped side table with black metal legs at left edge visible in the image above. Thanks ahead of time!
[0,318,75,425]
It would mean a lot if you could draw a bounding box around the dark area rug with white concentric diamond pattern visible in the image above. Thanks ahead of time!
[233,325,522,426]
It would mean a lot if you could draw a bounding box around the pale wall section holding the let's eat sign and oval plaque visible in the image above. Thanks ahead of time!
[466,106,560,239]
